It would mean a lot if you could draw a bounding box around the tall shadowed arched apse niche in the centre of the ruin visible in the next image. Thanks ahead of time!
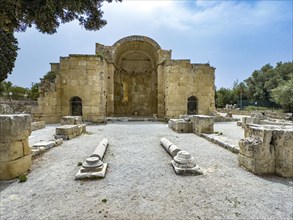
[113,36,160,116]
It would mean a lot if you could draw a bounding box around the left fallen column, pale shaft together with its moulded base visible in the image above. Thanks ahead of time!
[75,138,108,180]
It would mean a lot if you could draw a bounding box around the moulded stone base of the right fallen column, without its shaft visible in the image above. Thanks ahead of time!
[171,151,203,175]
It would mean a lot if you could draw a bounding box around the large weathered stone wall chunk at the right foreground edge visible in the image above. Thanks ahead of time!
[238,125,293,177]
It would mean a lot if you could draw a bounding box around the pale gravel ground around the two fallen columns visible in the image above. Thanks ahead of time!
[0,122,293,220]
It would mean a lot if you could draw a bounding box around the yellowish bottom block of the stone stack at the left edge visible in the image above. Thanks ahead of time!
[0,155,32,180]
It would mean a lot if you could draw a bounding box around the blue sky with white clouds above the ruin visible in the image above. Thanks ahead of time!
[8,0,293,88]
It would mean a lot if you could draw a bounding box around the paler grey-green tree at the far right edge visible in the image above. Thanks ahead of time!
[271,73,293,112]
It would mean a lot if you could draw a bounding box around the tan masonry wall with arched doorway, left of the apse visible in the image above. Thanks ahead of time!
[58,55,107,121]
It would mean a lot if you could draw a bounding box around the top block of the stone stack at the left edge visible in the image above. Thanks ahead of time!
[0,114,32,143]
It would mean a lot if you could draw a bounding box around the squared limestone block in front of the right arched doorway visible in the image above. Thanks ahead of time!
[191,115,214,134]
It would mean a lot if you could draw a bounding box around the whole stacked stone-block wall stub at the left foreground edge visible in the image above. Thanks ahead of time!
[0,114,32,180]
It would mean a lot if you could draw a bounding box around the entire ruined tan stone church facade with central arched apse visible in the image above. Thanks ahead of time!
[38,36,215,123]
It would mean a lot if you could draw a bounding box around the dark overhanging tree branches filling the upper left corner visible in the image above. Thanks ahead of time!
[0,0,121,81]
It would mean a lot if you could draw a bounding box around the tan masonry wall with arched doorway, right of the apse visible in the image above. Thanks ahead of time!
[164,60,215,118]
